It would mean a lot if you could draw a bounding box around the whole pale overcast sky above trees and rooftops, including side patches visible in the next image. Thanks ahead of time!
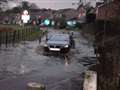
[4,0,98,9]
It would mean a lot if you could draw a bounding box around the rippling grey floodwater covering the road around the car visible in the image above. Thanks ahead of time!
[0,30,96,90]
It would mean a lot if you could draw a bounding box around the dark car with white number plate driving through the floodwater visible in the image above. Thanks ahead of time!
[44,34,71,53]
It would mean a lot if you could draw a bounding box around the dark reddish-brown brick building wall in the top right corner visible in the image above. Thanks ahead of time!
[96,0,120,20]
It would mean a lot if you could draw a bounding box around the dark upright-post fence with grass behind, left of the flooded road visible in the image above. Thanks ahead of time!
[0,28,43,48]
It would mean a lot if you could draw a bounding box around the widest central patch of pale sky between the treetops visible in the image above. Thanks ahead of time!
[26,0,79,9]
